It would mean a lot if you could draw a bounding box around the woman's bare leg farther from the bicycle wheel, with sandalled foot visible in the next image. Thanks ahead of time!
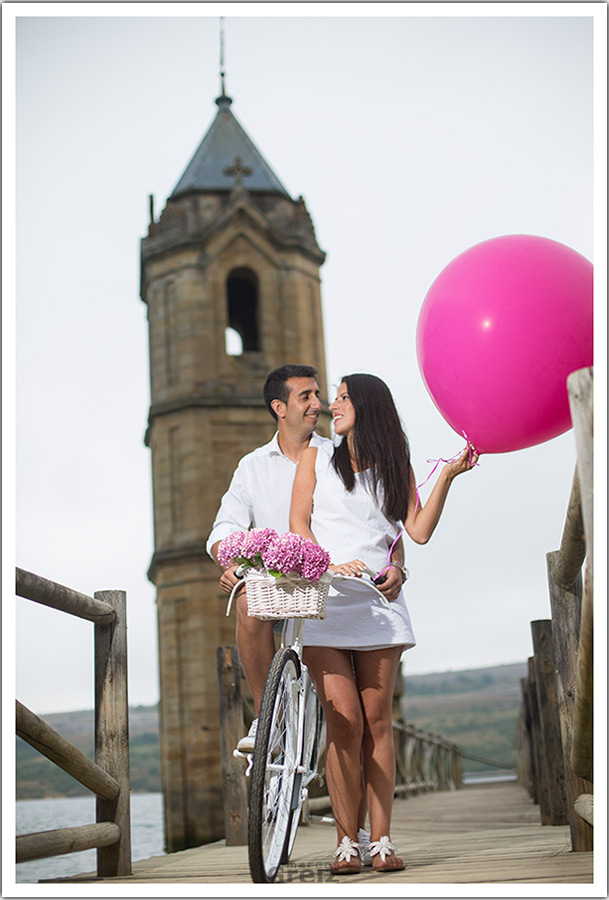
[353,647,403,867]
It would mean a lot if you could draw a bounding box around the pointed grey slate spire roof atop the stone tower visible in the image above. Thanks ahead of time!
[170,91,289,200]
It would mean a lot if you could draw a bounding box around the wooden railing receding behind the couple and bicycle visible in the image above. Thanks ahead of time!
[217,647,463,846]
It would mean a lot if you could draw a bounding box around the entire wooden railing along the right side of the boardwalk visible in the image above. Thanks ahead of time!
[515,369,594,851]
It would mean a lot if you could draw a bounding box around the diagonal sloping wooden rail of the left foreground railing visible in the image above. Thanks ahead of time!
[16,700,119,800]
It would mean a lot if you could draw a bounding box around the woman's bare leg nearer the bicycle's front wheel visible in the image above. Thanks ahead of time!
[304,647,363,868]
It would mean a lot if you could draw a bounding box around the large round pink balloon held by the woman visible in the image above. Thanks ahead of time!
[417,234,593,453]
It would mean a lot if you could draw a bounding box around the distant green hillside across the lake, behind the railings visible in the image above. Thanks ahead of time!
[17,663,526,800]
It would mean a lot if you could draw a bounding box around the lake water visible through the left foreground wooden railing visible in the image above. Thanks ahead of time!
[15,794,165,882]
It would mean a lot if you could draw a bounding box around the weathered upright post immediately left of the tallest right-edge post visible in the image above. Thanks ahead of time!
[546,553,593,851]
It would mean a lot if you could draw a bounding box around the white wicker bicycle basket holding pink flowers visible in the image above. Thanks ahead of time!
[244,568,330,619]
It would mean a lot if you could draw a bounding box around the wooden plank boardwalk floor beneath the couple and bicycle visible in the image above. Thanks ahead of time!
[48,782,593,893]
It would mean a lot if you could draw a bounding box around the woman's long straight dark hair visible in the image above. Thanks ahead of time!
[332,374,410,521]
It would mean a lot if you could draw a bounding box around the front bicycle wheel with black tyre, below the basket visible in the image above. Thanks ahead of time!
[248,648,302,883]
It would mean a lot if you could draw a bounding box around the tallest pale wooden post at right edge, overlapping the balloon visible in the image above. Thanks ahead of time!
[567,368,594,781]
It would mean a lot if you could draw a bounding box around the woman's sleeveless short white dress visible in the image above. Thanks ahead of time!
[304,444,415,650]
